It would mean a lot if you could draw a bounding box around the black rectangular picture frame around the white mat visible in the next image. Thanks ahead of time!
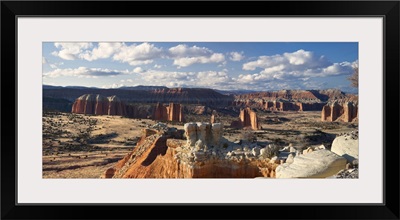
[0,1,400,219]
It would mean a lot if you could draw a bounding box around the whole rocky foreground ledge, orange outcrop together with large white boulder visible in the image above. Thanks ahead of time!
[102,122,358,178]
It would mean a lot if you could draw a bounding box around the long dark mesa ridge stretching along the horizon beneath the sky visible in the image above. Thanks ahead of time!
[47,85,358,114]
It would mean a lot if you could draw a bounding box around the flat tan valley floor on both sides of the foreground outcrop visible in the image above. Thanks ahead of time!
[43,111,358,178]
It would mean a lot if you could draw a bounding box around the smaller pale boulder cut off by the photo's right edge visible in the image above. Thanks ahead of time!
[331,136,358,163]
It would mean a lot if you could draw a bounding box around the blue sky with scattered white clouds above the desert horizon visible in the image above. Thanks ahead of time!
[42,42,358,93]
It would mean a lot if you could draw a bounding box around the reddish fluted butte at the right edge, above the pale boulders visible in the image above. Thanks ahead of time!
[321,102,358,122]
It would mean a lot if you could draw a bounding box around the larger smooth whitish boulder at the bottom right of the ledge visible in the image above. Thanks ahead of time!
[276,150,347,178]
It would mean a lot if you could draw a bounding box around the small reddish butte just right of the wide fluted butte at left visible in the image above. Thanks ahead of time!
[153,103,185,122]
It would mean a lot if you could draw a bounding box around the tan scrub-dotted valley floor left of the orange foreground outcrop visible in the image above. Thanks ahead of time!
[43,113,155,178]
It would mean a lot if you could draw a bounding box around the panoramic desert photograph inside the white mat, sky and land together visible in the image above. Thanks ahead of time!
[42,42,359,181]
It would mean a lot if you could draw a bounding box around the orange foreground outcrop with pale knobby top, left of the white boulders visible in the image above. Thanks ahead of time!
[104,123,278,178]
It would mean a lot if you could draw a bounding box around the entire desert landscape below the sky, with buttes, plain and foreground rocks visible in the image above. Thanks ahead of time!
[43,85,358,178]
